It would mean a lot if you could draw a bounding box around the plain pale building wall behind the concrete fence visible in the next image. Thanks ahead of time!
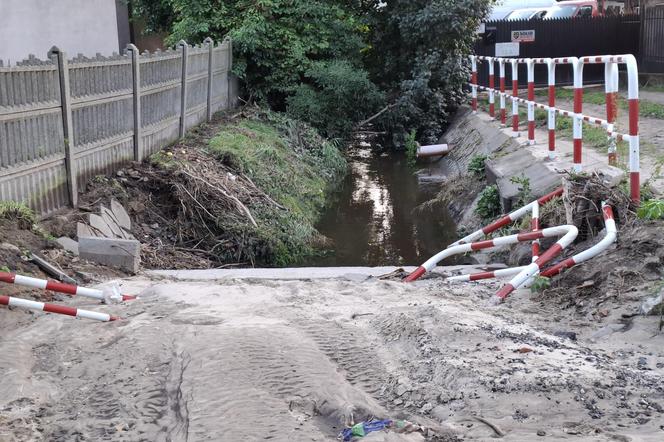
[0,0,119,65]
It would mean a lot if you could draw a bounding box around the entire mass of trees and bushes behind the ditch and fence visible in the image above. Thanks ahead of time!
[130,0,491,149]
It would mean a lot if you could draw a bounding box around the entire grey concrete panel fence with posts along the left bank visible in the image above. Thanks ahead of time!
[0,38,237,214]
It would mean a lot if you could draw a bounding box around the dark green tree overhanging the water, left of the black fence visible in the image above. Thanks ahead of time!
[367,0,491,146]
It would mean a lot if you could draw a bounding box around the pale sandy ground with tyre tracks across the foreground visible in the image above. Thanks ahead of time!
[0,272,664,441]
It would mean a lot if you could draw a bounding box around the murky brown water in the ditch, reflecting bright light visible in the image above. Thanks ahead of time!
[307,147,456,266]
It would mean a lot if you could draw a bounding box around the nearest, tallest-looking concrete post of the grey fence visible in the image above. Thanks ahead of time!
[48,46,78,207]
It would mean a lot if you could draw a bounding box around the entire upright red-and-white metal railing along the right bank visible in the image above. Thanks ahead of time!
[470,54,641,203]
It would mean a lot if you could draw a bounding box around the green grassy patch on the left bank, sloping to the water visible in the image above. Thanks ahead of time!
[209,113,346,266]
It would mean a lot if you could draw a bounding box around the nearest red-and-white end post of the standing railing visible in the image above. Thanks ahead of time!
[624,54,641,204]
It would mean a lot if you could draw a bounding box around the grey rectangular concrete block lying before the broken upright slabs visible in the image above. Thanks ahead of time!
[78,237,141,273]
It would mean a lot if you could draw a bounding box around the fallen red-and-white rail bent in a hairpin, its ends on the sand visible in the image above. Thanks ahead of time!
[404,226,578,282]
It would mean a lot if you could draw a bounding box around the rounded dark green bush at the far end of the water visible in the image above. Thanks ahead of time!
[286,60,384,138]
